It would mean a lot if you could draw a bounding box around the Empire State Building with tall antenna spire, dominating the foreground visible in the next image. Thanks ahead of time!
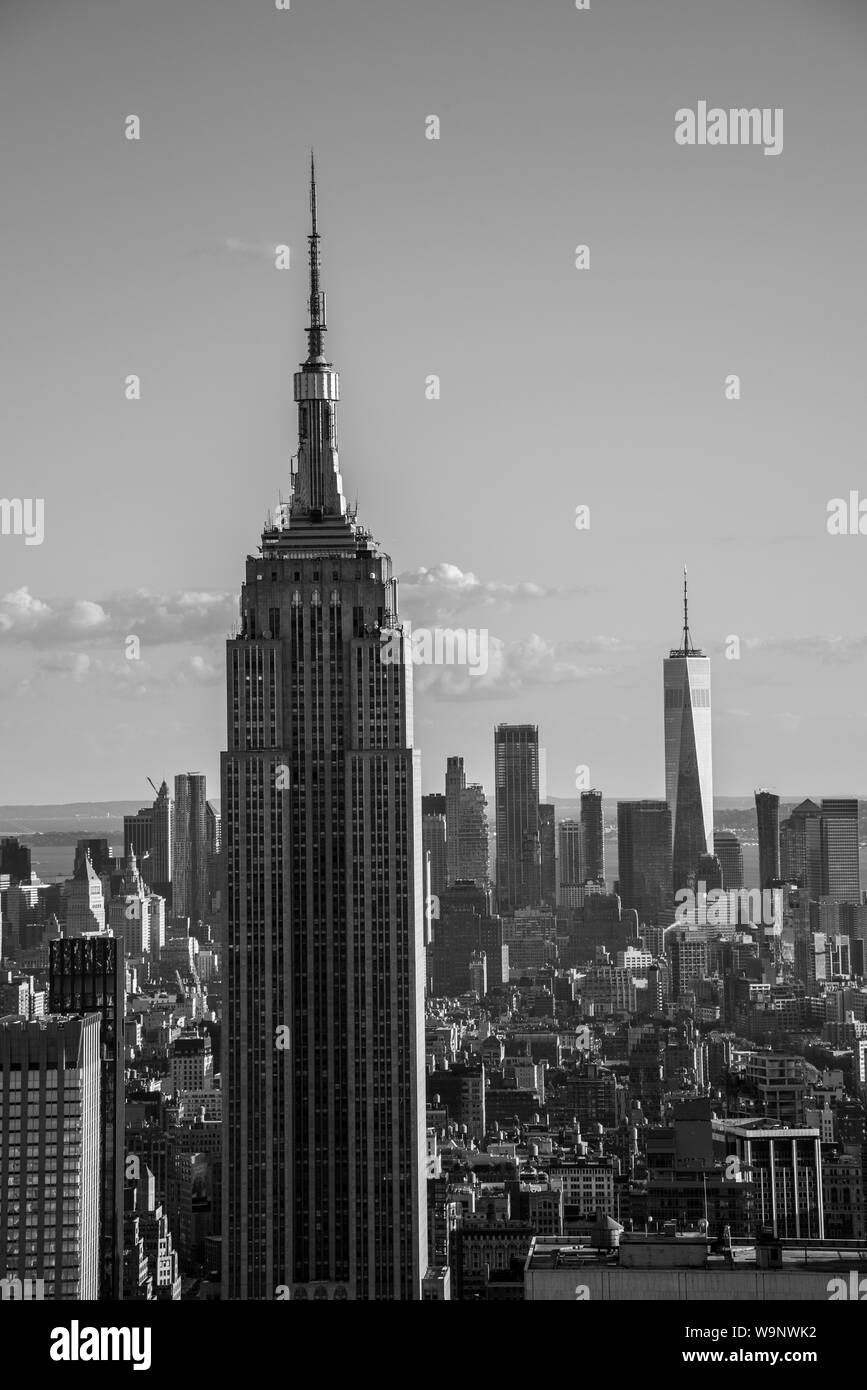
[222,164,427,1300]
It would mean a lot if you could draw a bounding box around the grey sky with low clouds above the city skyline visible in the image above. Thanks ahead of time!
[0,0,867,803]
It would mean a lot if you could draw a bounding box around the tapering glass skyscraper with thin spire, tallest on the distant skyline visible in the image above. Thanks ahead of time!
[663,570,713,891]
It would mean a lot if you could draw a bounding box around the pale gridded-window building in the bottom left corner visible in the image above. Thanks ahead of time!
[0,1013,101,1302]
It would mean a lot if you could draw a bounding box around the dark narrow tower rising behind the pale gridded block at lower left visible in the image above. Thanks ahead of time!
[49,937,125,1300]
